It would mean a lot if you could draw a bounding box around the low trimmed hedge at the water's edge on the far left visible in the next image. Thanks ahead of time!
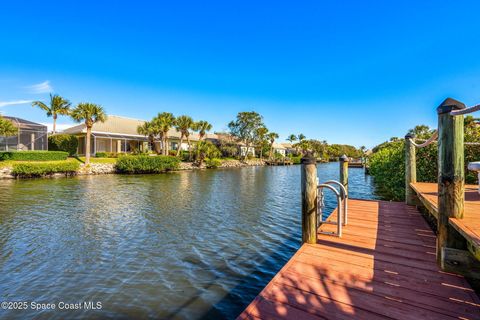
[12,161,80,178]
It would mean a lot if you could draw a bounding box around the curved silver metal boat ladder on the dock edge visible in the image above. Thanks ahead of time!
[317,180,348,237]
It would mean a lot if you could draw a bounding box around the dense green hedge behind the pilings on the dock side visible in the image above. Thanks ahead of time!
[368,140,480,201]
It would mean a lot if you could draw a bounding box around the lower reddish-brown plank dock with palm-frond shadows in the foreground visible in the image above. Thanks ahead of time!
[238,200,480,320]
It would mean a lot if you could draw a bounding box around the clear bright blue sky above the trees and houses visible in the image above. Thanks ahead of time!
[0,0,480,147]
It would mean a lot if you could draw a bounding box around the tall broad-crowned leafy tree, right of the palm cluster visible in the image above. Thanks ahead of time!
[228,111,264,160]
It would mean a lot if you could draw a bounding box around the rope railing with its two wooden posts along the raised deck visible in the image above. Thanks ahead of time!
[405,98,480,274]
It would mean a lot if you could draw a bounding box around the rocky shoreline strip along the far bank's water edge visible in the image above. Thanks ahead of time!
[0,159,266,180]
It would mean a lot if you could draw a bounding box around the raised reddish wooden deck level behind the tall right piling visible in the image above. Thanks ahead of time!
[410,182,480,260]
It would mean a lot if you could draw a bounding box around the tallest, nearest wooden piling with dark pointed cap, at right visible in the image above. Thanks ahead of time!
[437,98,465,266]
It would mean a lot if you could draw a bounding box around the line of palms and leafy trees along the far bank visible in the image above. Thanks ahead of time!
[0,94,365,164]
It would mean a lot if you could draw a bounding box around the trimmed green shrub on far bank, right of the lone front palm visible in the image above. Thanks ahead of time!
[116,155,180,173]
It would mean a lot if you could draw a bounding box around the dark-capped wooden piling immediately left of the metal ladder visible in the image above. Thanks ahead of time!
[301,154,318,244]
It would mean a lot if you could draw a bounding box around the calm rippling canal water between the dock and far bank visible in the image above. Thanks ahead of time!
[0,163,375,319]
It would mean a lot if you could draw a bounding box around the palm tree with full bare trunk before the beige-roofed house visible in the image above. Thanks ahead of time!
[70,102,107,165]
